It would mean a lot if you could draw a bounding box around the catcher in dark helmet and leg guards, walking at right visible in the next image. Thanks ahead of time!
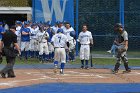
[112,23,131,74]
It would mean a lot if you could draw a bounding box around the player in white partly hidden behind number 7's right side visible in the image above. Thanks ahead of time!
[64,22,76,61]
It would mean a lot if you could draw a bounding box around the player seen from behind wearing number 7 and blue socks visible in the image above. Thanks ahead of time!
[52,29,69,74]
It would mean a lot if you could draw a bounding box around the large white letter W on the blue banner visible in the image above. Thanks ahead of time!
[41,0,67,22]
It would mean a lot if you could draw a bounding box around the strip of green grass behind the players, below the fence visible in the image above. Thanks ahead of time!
[2,58,140,66]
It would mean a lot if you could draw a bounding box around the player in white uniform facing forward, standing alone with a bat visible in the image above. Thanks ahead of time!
[78,25,93,69]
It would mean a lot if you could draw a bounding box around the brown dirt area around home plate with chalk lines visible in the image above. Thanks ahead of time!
[0,69,140,89]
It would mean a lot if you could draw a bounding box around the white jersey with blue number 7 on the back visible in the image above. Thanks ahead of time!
[52,33,68,47]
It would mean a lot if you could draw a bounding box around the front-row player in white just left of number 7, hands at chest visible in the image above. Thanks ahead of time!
[37,27,49,62]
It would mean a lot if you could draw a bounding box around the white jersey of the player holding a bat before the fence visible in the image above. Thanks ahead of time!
[78,31,93,44]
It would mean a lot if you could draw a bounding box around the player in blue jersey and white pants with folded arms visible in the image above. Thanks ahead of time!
[21,21,31,59]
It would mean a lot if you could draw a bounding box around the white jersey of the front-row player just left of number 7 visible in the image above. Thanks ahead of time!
[37,31,49,43]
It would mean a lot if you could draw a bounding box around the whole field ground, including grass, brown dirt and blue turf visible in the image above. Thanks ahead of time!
[0,51,140,93]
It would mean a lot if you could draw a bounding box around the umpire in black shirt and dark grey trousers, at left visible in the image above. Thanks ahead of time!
[0,26,20,78]
